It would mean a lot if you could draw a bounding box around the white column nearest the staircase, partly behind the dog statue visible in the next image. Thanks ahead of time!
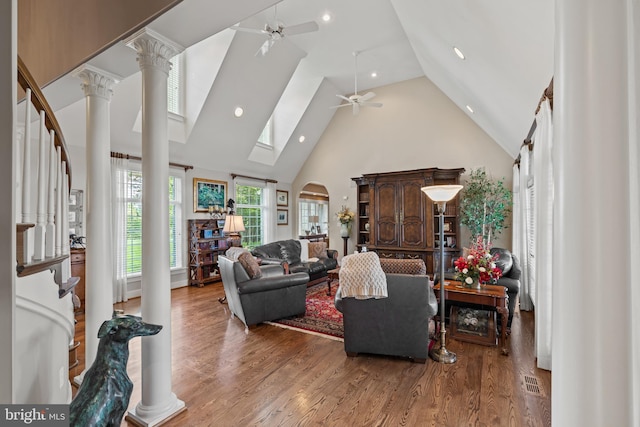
[71,64,119,383]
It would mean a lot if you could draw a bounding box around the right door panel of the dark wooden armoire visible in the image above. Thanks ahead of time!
[398,180,426,248]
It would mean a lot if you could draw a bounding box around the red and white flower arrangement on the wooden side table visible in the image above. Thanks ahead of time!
[453,236,502,286]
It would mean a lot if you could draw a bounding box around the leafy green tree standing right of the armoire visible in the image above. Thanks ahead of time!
[460,168,512,245]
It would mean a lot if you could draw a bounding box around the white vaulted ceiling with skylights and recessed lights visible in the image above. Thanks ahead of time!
[45,0,554,182]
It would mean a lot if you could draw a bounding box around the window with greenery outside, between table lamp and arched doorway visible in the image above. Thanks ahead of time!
[236,184,267,249]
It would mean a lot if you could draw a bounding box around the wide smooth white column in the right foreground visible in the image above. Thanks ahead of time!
[552,0,640,426]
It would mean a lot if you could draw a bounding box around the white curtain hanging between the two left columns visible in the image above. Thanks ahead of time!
[111,158,129,303]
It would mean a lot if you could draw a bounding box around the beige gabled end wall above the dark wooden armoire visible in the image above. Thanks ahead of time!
[289,77,516,254]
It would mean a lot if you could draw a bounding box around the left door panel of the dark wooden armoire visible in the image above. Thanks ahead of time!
[375,182,398,246]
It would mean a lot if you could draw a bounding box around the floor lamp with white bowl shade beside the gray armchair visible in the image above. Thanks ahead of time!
[421,185,462,363]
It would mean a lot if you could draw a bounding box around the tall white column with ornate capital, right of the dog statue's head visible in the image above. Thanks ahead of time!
[126,28,185,426]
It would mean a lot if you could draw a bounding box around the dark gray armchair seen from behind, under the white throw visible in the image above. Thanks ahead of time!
[335,274,437,363]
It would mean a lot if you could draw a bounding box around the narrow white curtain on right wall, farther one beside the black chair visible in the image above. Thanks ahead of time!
[514,146,533,311]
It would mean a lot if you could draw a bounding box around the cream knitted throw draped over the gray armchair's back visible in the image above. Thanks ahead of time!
[339,252,389,299]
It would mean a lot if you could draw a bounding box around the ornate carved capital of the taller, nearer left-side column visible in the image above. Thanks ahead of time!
[125,28,184,75]
